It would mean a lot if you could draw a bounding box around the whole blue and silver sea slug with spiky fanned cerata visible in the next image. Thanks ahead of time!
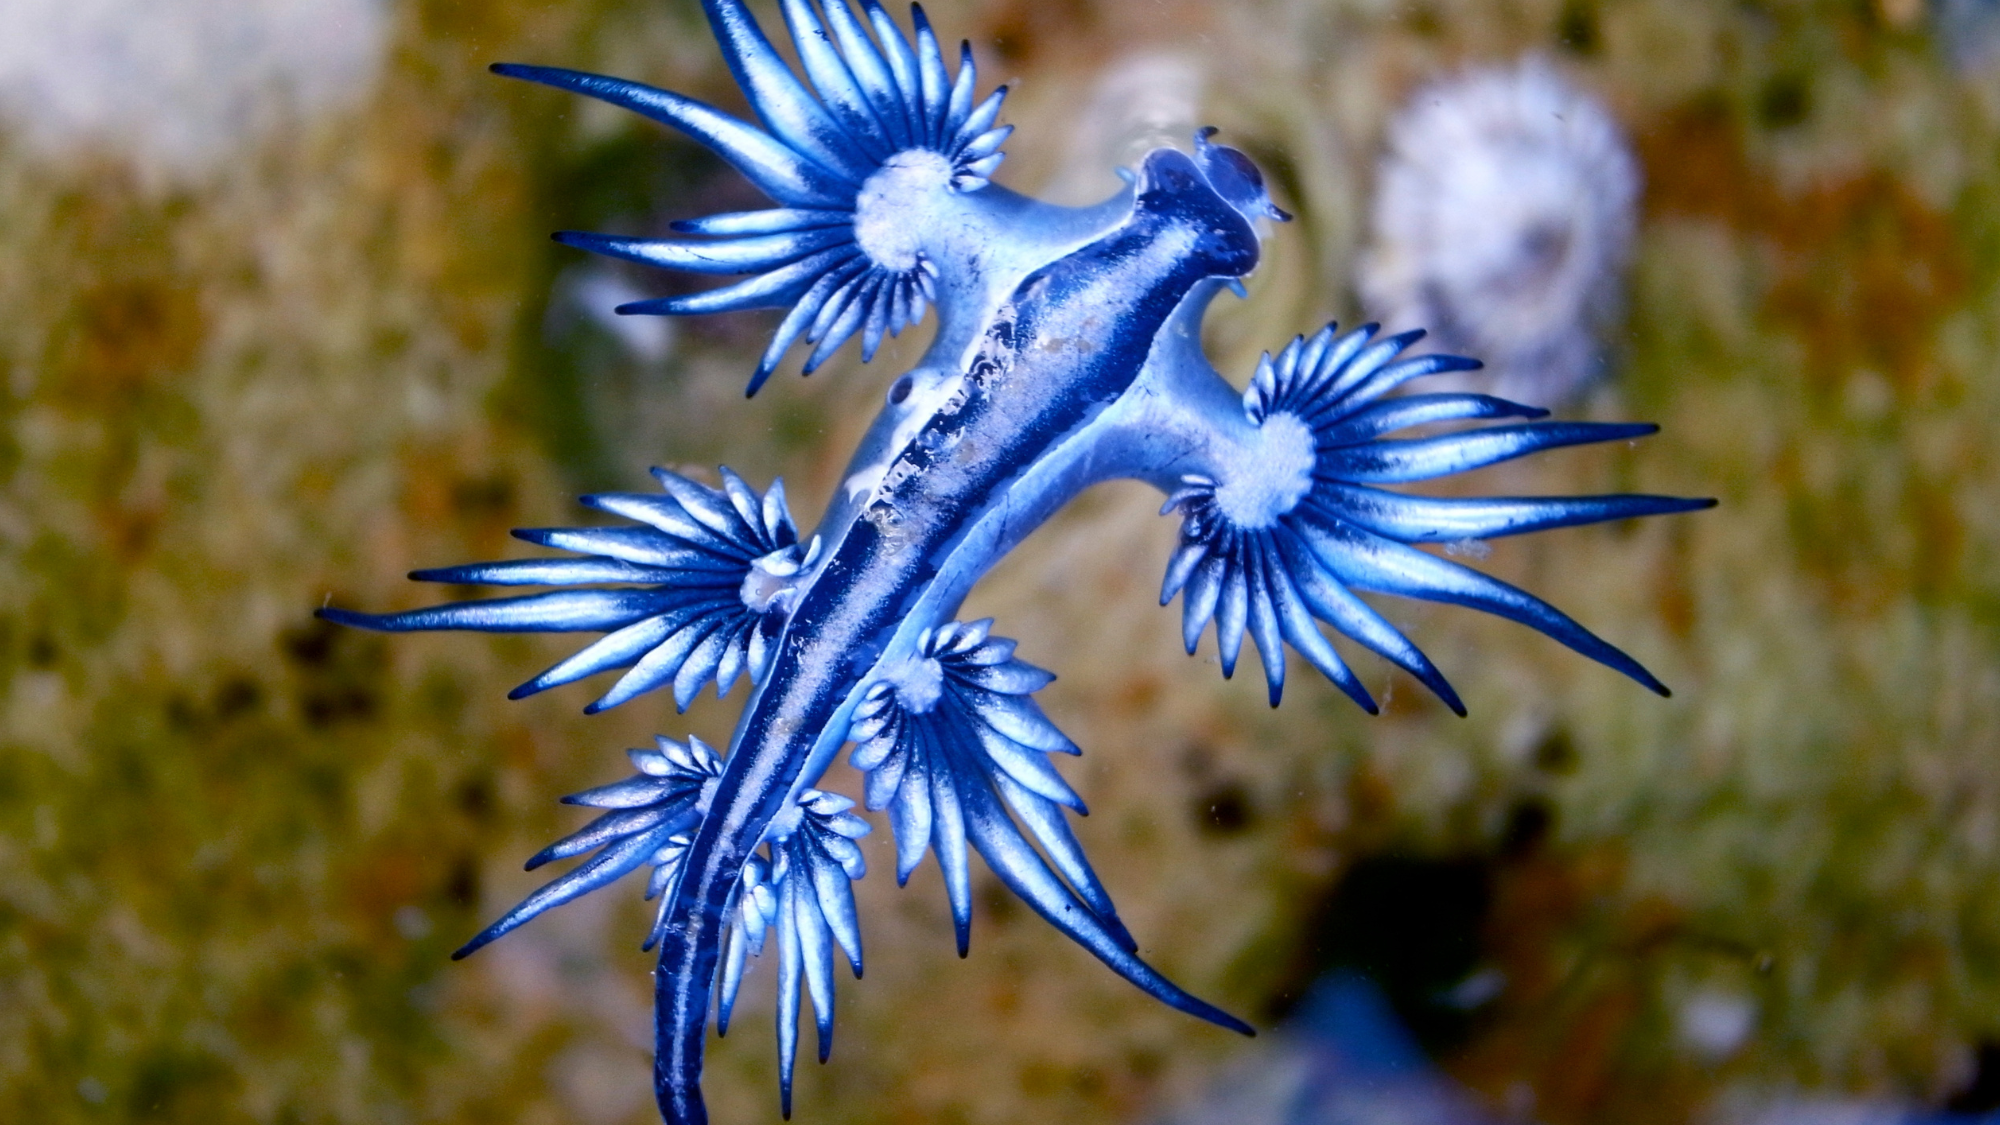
[322,0,1708,1125]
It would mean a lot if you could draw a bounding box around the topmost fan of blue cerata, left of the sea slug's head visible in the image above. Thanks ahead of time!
[494,0,1014,394]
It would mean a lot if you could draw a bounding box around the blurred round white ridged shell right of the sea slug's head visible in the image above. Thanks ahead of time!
[1360,58,1640,406]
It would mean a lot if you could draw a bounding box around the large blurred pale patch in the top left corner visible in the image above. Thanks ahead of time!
[0,0,388,176]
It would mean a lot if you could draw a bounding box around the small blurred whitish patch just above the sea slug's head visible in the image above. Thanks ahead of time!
[1040,52,1200,206]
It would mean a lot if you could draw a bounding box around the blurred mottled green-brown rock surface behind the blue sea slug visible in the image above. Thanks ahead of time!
[0,0,2000,1125]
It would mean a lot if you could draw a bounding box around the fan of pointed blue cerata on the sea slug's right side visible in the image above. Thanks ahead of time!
[1160,324,1714,715]
